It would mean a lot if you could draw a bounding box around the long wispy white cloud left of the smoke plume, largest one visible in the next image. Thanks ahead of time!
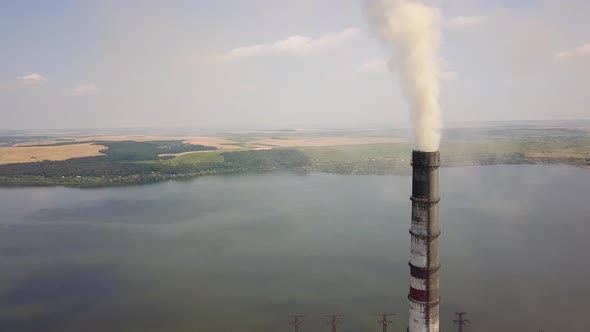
[201,28,359,63]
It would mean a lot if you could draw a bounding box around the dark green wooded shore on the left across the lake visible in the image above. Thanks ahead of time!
[0,148,309,186]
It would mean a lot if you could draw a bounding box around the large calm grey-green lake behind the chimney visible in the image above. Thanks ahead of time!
[0,166,590,332]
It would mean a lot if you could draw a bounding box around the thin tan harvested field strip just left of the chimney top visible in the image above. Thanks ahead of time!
[250,137,407,148]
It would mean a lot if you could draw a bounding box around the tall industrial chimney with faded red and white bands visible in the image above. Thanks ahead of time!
[408,151,440,332]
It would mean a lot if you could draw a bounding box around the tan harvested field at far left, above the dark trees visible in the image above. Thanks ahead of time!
[0,143,107,164]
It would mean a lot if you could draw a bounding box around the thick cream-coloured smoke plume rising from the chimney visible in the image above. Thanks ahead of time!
[365,0,442,152]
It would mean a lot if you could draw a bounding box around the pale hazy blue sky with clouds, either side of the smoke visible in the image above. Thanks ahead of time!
[0,0,590,129]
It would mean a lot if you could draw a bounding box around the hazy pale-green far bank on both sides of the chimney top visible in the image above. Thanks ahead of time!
[299,137,590,174]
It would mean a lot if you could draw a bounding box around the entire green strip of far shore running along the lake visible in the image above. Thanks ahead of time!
[0,129,590,185]
